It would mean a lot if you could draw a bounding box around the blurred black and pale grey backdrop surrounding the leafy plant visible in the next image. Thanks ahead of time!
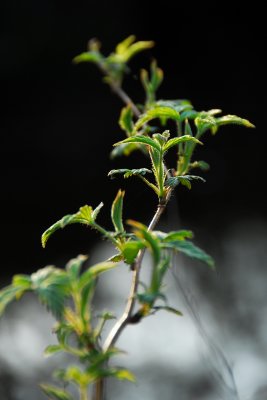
[0,0,267,400]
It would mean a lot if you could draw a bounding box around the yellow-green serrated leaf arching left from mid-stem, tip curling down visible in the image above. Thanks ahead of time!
[42,203,103,247]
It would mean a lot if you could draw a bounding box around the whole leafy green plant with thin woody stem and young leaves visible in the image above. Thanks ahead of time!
[0,36,253,400]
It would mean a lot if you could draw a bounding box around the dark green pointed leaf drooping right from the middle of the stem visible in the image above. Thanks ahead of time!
[162,240,215,269]
